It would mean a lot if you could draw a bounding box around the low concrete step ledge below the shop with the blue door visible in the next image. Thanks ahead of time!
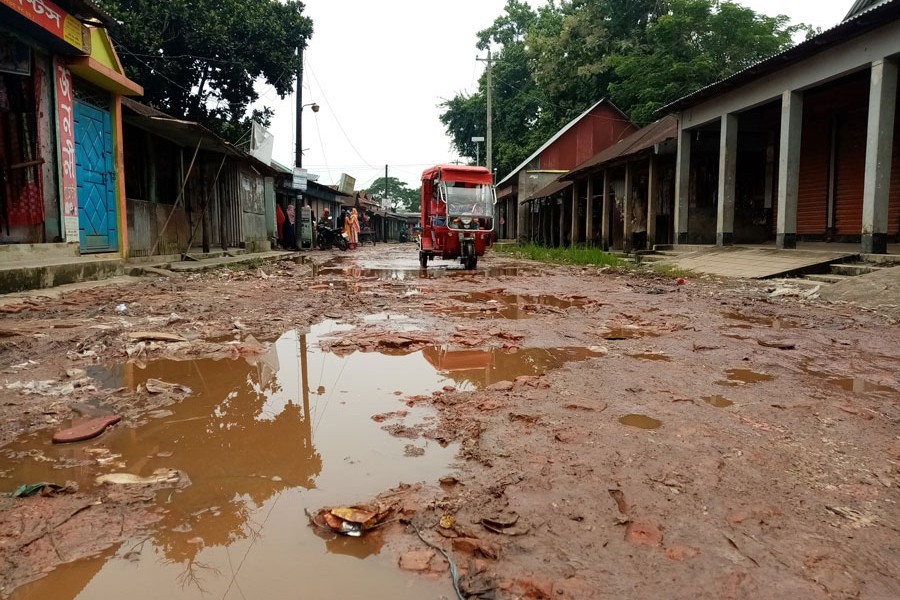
[0,256,125,294]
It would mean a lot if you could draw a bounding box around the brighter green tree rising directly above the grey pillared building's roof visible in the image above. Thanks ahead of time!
[607,0,808,124]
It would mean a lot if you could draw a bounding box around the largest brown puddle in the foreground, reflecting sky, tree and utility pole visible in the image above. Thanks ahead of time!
[0,322,456,600]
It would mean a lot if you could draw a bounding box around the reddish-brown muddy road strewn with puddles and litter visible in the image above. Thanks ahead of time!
[0,244,900,600]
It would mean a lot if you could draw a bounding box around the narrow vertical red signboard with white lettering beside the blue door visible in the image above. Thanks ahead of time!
[53,59,78,242]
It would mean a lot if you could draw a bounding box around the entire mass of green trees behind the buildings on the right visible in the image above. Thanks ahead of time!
[441,0,810,178]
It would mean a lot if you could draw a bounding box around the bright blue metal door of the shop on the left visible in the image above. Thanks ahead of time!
[75,99,119,253]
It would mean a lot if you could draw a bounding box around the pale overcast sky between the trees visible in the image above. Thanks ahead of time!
[260,0,853,190]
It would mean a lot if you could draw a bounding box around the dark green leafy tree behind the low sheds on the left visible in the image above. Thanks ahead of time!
[98,0,312,140]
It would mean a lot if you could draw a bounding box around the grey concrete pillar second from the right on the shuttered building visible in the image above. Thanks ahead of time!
[775,90,803,249]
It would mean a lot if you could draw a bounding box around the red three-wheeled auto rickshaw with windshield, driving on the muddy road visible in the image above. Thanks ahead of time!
[419,165,497,270]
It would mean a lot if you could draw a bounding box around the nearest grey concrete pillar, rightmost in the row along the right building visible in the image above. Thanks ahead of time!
[861,59,897,254]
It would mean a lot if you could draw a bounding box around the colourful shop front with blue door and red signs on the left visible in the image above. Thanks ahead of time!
[0,0,142,254]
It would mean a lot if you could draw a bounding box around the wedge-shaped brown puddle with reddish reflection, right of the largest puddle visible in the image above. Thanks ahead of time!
[422,346,603,391]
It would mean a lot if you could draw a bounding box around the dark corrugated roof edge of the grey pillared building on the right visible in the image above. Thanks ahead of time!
[657,0,900,113]
